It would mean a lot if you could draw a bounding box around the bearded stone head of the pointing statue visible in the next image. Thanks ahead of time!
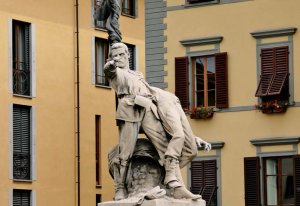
[109,43,130,69]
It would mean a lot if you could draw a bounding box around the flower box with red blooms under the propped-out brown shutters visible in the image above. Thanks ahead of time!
[256,100,289,114]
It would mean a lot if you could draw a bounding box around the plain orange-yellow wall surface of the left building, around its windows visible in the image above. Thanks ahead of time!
[0,0,145,206]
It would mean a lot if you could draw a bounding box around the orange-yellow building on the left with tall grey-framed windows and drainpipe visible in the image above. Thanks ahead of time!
[0,0,145,206]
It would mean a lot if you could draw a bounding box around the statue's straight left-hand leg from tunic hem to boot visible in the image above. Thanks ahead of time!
[114,121,140,200]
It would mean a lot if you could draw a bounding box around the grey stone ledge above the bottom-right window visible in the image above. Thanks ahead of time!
[250,137,300,146]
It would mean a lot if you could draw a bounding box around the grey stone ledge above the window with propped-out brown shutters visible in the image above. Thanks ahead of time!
[250,27,297,39]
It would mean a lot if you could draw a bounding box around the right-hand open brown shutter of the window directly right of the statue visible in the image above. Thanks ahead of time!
[215,52,228,108]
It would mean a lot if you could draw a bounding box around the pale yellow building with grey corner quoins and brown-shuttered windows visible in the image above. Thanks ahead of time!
[145,0,300,206]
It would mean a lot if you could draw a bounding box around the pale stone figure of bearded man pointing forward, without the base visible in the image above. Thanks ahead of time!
[104,43,211,200]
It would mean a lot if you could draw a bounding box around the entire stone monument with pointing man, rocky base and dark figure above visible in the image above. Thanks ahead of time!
[94,0,211,206]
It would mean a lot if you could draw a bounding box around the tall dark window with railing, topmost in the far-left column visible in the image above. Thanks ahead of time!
[12,20,32,96]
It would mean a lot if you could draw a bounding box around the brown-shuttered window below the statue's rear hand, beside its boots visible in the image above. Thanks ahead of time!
[191,160,218,206]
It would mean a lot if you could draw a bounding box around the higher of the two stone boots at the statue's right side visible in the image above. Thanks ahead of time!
[164,156,182,188]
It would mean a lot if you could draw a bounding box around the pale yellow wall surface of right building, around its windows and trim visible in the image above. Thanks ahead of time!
[164,0,300,206]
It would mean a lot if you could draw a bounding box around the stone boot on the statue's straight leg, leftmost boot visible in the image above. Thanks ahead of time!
[114,165,126,201]
